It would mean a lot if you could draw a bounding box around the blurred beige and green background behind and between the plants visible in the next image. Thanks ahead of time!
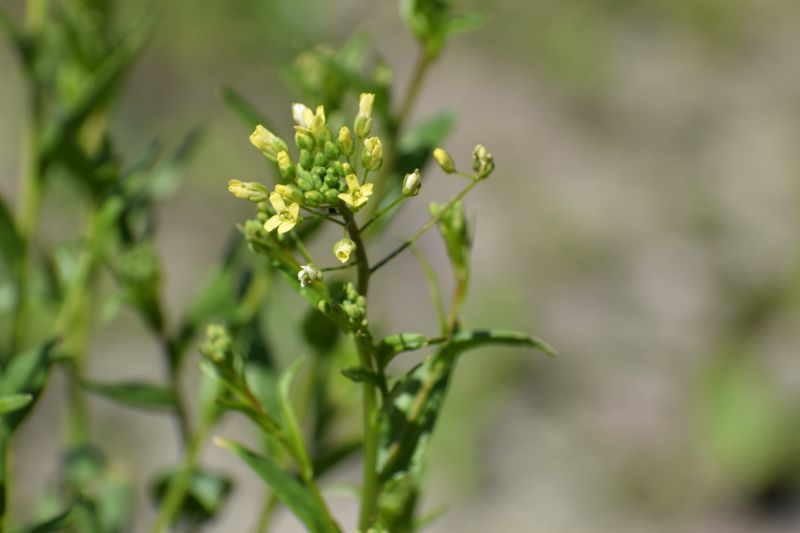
[0,0,800,533]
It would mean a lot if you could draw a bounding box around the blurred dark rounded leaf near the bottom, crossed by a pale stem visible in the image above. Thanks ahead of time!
[151,470,233,524]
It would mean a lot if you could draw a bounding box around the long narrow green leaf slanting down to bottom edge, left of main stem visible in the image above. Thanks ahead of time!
[215,438,339,533]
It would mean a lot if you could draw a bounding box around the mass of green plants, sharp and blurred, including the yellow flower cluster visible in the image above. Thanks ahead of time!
[0,0,553,532]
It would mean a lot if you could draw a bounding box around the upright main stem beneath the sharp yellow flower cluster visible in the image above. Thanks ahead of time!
[339,207,380,531]
